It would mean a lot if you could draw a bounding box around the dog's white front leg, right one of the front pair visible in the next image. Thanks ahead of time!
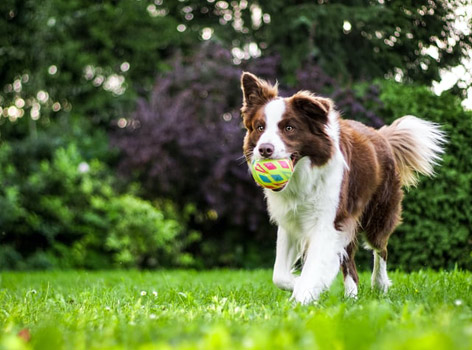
[292,227,344,304]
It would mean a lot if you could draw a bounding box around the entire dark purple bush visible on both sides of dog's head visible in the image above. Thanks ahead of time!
[112,43,381,266]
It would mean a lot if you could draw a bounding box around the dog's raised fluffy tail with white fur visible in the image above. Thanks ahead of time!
[379,115,446,187]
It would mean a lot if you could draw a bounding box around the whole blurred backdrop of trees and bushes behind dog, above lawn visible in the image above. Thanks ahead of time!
[0,0,472,271]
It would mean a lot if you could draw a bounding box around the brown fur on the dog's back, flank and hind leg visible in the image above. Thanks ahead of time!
[335,120,403,274]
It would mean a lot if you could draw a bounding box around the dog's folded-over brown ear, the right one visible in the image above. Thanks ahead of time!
[290,91,333,123]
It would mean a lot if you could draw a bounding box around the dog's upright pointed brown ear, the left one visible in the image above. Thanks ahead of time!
[241,72,278,114]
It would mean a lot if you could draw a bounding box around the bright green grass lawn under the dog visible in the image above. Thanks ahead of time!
[0,270,472,350]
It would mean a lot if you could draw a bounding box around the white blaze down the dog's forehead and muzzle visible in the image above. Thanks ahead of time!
[254,98,290,159]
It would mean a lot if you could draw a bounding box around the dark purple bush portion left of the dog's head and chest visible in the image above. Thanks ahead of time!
[114,44,264,235]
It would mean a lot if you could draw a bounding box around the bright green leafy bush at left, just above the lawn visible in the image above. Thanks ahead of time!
[0,144,191,268]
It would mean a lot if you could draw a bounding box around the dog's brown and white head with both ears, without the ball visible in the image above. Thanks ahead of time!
[241,73,338,166]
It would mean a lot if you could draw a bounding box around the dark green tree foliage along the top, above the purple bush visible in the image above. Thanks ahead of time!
[0,0,472,127]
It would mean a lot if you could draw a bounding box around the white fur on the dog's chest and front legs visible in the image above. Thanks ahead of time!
[265,113,349,304]
